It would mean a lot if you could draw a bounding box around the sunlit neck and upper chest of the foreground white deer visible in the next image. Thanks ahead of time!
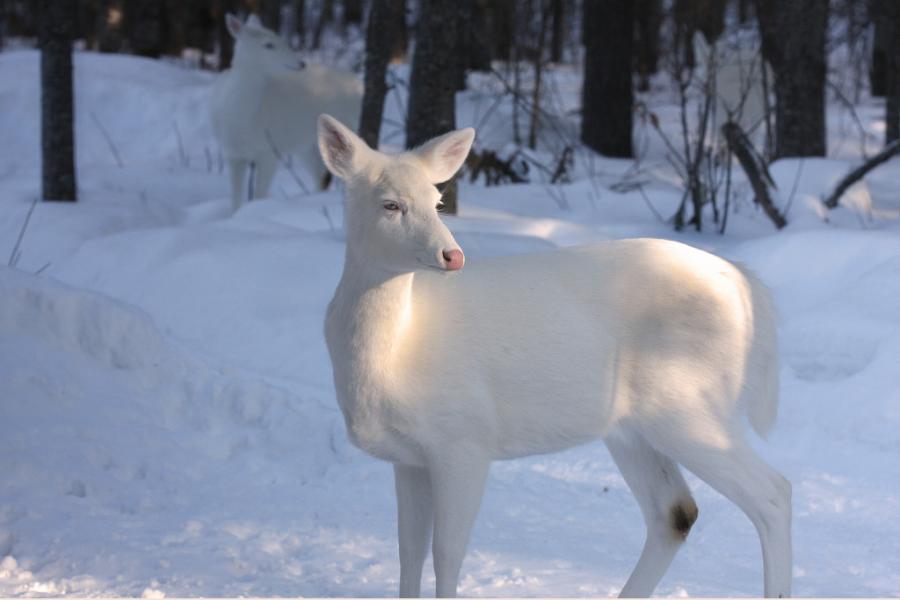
[325,255,414,415]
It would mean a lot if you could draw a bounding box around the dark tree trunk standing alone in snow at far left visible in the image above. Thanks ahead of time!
[39,0,76,202]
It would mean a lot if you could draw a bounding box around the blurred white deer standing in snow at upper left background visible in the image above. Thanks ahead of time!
[211,15,362,211]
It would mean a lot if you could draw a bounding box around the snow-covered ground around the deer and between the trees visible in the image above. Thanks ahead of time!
[0,51,900,597]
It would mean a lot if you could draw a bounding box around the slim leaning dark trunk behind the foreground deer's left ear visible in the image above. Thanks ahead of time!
[359,0,403,149]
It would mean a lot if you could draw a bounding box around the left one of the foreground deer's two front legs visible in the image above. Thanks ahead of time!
[394,465,434,598]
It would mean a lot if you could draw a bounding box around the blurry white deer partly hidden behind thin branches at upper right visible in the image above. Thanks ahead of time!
[694,31,775,135]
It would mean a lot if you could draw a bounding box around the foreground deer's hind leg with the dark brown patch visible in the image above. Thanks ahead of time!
[605,434,697,598]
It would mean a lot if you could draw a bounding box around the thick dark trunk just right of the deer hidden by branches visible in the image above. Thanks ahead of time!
[756,0,828,158]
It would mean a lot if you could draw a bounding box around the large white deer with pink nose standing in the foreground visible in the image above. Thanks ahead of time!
[319,115,791,597]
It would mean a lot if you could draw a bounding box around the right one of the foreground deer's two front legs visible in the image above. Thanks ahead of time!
[429,446,490,598]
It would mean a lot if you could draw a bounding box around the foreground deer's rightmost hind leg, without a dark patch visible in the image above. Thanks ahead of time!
[660,434,793,597]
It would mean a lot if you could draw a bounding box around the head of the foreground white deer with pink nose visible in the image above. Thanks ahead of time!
[319,115,475,273]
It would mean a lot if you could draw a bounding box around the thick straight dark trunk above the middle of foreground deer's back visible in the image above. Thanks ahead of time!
[581,0,633,157]
